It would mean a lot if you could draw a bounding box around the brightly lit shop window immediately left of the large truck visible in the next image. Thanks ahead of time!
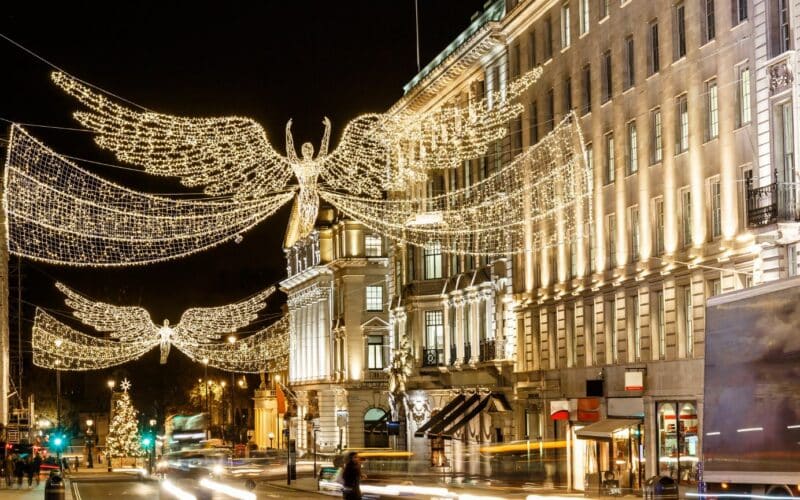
[658,402,699,483]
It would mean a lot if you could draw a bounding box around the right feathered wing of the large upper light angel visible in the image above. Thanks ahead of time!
[320,68,542,198]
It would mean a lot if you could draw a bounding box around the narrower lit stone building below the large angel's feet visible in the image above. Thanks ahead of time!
[281,207,389,453]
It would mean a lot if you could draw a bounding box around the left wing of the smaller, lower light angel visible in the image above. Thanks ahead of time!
[56,283,158,341]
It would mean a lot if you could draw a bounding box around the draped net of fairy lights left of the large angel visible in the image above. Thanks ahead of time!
[3,126,293,266]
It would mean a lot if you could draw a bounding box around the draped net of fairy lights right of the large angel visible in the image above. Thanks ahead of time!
[321,116,592,255]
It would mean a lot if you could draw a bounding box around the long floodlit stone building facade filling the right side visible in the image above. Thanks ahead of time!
[390,0,800,490]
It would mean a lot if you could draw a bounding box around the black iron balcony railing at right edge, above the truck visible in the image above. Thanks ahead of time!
[747,182,800,227]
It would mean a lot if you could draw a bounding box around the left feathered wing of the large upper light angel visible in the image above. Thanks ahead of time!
[52,72,292,199]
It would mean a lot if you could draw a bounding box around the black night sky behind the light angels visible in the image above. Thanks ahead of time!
[0,0,484,417]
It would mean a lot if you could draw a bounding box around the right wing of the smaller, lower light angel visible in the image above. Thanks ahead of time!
[174,287,275,343]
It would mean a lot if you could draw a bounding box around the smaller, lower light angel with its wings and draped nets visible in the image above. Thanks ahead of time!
[32,283,291,373]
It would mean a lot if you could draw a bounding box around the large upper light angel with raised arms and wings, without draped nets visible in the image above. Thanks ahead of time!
[43,68,542,252]
